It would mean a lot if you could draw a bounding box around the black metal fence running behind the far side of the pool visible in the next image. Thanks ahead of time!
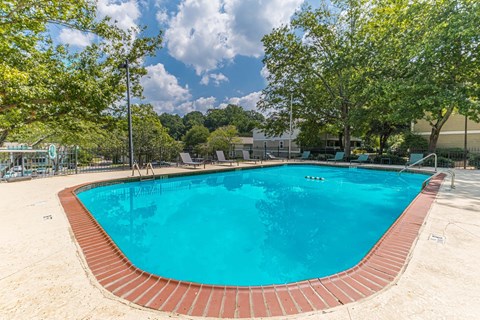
[0,147,480,180]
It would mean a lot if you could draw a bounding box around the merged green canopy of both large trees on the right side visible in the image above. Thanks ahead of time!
[258,0,480,154]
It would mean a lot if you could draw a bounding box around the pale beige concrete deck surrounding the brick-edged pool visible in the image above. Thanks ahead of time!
[0,165,480,319]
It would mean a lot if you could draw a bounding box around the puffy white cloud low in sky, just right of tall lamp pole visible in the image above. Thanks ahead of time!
[141,63,192,113]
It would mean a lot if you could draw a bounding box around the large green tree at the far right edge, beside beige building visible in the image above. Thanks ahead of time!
[368,0,480,152]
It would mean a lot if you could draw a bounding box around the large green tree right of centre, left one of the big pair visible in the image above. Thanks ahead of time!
[258,1,370,156]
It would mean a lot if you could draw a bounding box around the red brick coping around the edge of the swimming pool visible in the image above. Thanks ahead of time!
[59,175,444,318]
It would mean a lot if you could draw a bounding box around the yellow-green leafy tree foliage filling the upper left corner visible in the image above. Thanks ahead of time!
[0,0,161,144]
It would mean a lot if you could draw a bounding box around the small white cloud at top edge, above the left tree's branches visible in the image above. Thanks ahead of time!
[97,0,141,30]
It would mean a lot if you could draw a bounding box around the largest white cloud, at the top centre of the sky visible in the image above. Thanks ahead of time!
[165,0,304,75]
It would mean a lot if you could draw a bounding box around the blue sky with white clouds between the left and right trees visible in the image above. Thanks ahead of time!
[55,0,317,115]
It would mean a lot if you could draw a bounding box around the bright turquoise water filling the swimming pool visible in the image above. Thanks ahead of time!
[78,165,426,286]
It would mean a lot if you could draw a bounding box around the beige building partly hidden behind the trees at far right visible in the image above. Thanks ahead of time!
[412,114,480,149]
